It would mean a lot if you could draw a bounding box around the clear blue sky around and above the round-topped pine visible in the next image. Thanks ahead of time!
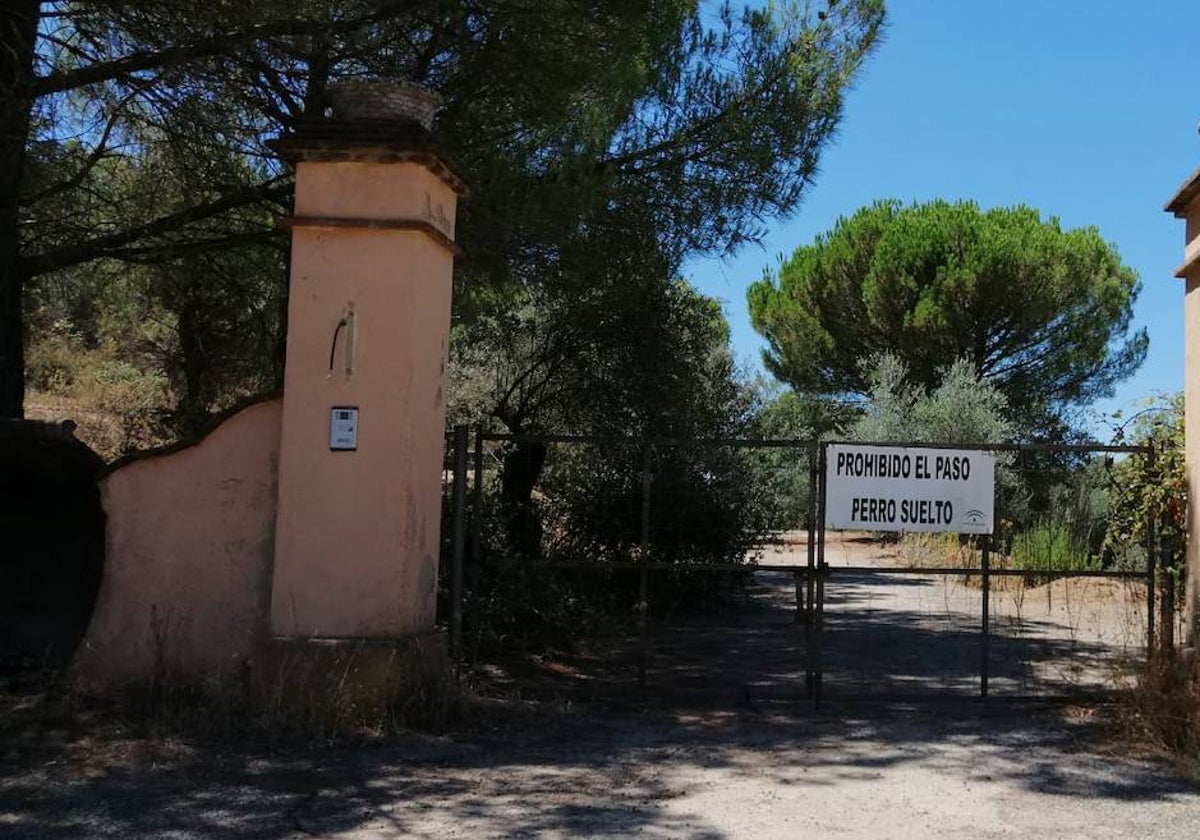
[685,0,1200,434]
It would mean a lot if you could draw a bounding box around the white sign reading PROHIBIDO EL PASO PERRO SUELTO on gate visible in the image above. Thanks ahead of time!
[826,444,996,534]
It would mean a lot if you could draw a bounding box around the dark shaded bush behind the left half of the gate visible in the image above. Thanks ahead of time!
[453,440,779,653]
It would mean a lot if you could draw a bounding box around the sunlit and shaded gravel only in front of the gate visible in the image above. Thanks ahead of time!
[0,702,1200,840]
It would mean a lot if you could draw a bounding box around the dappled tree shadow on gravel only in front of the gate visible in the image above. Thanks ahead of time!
[0,686,1189,839]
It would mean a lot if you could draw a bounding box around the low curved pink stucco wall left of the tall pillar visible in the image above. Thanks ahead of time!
[76,400,282,683]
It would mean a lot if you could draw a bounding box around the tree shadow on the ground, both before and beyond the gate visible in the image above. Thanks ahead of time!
[0,568,1190,840]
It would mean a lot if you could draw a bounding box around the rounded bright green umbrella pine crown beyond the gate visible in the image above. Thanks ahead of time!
[748,200,1148,433]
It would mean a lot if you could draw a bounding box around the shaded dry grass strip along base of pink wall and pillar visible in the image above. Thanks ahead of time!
[25,646,472,743]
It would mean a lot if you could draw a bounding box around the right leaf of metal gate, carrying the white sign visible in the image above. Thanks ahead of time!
[808,443,1174,704]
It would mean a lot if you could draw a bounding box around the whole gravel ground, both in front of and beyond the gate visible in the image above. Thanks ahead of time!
[0,535,1200,840]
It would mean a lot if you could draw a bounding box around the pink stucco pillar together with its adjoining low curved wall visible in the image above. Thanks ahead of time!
[76,149,457,683]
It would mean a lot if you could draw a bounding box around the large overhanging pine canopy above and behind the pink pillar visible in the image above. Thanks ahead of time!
[0,0,883,415]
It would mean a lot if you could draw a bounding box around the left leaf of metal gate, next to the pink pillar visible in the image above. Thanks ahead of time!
[443,427,818,704]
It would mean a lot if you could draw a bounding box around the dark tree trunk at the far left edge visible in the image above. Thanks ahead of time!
[0,0,41,419]
